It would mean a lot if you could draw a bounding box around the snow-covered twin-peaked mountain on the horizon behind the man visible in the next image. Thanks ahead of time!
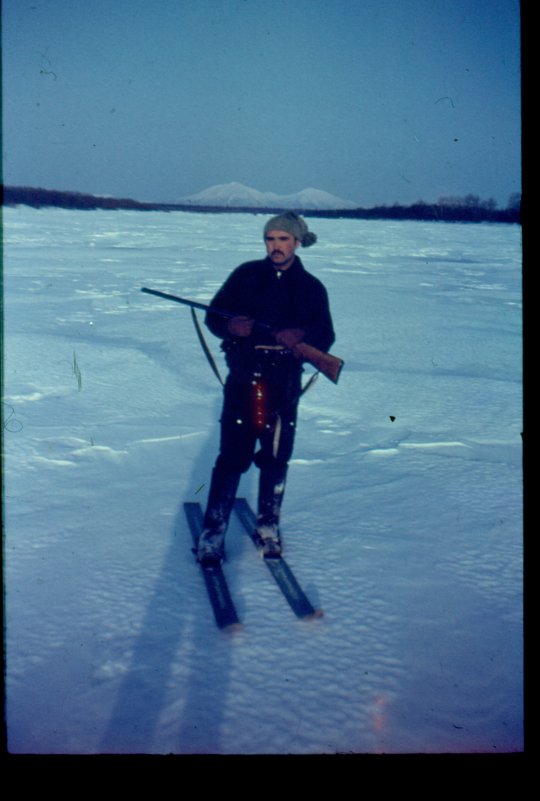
[179,182,358,210]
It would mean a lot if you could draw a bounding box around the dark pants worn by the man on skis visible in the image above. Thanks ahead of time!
[204,354,301,535]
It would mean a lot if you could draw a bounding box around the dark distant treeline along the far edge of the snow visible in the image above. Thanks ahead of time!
[2,186,521,223]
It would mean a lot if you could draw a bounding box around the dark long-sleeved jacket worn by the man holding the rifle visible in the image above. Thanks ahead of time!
[206,257,335,351]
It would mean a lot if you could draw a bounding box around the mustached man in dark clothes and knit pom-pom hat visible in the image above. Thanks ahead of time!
[197,212,335,564]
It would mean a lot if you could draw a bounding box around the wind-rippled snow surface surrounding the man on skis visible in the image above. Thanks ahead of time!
[3,207,523,754]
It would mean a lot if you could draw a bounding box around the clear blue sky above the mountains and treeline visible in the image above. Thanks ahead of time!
[2,0,521,208]
